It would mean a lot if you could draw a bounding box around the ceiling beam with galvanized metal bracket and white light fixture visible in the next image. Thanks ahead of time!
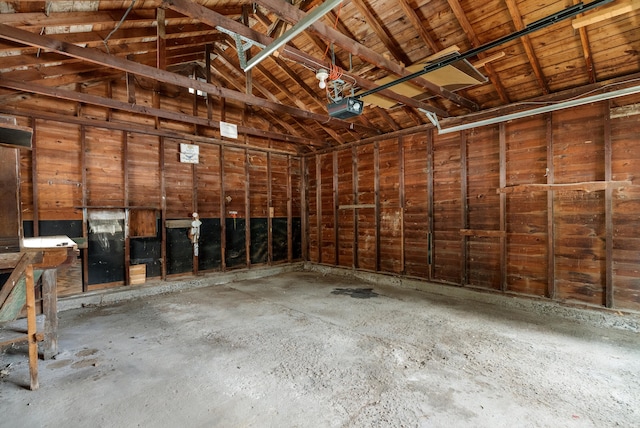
[164,0,449,117]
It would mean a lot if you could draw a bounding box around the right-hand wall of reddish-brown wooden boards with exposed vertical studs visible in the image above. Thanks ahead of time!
[305,96,640,310]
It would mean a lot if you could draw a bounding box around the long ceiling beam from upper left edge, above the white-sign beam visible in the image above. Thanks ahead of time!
[0,24,379,134]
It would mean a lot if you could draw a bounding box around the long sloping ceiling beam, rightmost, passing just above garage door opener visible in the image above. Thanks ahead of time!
[252,0,479,111]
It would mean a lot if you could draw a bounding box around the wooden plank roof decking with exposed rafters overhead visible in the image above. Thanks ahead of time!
[0,0,640,151]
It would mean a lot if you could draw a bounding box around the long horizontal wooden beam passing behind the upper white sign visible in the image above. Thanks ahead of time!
[0,75,327,147]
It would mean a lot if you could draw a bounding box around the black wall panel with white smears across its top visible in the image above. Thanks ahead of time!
[88,220,124,284]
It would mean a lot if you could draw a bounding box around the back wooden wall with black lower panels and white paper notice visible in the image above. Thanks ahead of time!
[10,81,303,295]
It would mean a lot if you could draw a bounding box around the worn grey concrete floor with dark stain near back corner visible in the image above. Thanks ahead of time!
[0,272,640,427]
